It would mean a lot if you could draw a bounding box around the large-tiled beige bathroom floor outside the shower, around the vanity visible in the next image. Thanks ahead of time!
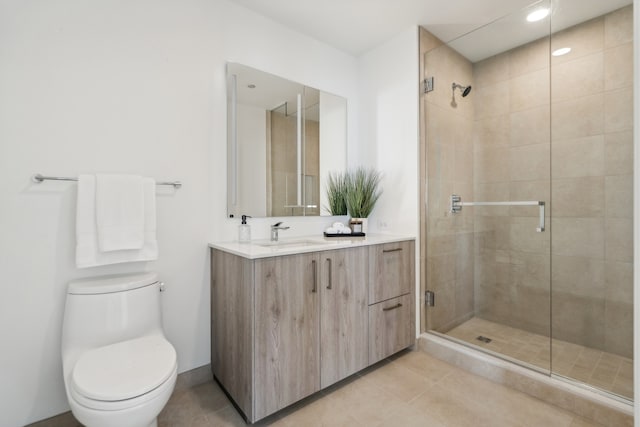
[158,351,597,427]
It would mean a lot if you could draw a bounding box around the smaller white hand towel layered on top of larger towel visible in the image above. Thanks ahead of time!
[96,175,145,252]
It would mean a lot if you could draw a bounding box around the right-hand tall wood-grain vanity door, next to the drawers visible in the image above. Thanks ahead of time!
[320,247,369,388]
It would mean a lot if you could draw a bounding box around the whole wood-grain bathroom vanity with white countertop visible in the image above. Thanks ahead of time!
[210,235,415,422]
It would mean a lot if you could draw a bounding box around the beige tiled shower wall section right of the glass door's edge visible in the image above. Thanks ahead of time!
[551,6,633,357]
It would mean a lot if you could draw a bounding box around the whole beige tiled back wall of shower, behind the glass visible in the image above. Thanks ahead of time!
[472,6,633,357]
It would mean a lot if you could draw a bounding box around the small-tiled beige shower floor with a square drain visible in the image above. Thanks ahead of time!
[447,317,633,399]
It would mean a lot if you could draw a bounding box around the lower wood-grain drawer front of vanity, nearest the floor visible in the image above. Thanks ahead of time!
[369,294,413,365]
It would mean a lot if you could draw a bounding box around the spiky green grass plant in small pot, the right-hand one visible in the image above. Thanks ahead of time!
[345,167,382,233]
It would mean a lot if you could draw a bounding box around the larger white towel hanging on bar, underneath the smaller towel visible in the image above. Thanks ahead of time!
[76,175,158,268]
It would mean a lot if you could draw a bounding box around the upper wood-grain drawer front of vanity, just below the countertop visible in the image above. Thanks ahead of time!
[369,241,415,304]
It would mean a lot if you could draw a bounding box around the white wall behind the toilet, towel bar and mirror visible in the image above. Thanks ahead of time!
[0,0,357,427]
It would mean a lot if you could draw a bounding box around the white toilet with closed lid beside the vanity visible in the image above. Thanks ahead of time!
[62,273,178,427]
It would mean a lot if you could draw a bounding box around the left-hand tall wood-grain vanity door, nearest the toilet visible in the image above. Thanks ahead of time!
[254,254,320,419]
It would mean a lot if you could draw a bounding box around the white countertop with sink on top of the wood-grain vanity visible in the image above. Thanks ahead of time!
[209,234,415,259]
